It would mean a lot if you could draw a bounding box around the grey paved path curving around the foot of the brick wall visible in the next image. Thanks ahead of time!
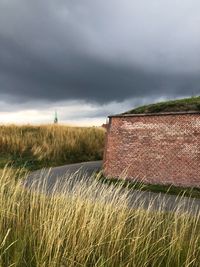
[25,161,200,214]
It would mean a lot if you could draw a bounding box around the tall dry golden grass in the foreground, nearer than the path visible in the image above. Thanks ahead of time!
[0,169,200,267]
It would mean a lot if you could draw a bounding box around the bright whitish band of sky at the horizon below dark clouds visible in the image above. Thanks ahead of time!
[0,97,181,126]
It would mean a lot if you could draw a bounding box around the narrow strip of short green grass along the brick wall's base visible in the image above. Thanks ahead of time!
[97,175,200,198]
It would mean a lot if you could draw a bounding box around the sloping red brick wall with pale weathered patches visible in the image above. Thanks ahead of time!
[104,113,200,187]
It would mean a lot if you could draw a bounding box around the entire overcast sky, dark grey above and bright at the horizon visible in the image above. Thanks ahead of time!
[0,0,200,125]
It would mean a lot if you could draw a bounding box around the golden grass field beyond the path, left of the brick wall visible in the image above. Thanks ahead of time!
[0,125,105,170]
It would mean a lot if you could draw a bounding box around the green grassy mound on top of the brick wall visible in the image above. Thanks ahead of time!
[123,96,200,115]
